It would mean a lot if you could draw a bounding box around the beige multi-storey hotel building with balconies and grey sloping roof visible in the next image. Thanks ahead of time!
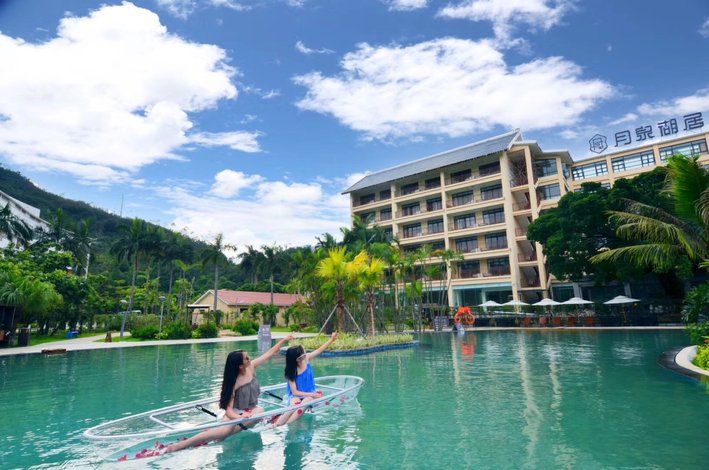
[344,126,709,306]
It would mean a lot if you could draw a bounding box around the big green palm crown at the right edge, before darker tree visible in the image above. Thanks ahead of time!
[591,155,709,272]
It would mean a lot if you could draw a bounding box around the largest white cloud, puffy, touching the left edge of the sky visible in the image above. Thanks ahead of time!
[0,2,252,183]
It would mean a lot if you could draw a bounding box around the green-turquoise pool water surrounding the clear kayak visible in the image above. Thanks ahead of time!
[0,330,709,469]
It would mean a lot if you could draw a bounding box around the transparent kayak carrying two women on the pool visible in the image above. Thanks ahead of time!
[84,375,364,441]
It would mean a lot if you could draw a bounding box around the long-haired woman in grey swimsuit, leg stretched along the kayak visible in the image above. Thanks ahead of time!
[165,335,294,452]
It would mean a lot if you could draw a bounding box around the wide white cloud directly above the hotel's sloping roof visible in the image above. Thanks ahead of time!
[294,38,615,139]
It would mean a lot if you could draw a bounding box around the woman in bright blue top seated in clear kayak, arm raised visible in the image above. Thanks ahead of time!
[274,332,337,426]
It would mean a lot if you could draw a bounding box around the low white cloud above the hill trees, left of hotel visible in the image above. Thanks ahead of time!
[158,172,349,247]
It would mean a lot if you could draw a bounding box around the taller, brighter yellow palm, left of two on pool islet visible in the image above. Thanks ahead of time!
[316,246,367,331]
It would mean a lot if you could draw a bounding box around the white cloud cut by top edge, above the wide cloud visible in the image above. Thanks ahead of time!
[437,0,575,41]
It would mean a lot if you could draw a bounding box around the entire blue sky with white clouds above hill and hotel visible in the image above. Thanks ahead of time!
[0,0,709,250]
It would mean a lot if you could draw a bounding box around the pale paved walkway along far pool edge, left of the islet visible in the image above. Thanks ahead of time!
[0,333,315,356]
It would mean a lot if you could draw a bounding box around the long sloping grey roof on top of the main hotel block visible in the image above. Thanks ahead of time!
[342,129,521,194]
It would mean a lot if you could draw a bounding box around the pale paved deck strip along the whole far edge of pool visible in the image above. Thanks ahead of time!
[0,326,684,357]
